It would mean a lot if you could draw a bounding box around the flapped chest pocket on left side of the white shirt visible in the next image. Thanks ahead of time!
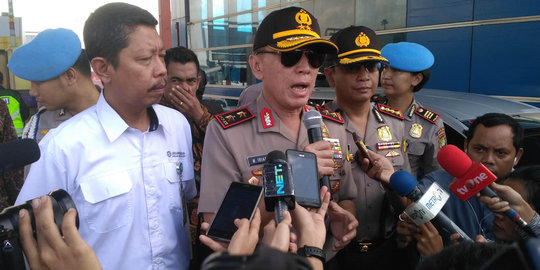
[80,171,134,233]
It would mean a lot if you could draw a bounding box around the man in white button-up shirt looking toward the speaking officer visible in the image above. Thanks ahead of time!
[17,3,196,269]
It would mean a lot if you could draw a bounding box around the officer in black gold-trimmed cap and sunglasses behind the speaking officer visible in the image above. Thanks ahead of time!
[323,26,416,269]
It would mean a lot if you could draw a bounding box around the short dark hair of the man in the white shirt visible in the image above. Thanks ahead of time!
[83,3,157,67]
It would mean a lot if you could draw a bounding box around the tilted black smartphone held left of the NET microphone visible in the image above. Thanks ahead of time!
[206,182,262,242]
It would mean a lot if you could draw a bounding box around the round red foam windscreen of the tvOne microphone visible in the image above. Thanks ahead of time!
[437,144,473,178]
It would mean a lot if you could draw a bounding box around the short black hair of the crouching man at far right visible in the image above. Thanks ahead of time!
[465,113,523,153]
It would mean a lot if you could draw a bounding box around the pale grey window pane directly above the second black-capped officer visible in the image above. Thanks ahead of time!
[354,0,407,30]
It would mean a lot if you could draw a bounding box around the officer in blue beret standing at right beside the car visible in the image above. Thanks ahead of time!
[381,42,446,179]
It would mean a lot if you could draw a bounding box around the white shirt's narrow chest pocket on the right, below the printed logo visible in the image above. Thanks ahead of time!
[163,160,183,213]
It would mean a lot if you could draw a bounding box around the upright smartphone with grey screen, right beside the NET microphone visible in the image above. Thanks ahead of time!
[287,149,321,208]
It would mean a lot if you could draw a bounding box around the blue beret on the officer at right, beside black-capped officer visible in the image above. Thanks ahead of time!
[381,42,435,72]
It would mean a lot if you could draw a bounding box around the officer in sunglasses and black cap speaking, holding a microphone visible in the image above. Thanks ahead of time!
[199,7,356,255]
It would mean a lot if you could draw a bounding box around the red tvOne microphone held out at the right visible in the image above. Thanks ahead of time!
[437,144,536,236]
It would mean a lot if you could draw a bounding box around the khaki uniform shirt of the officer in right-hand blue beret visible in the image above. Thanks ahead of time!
[404,100,446,177]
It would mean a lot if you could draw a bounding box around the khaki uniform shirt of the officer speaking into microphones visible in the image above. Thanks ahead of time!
[199,95,356,213]
